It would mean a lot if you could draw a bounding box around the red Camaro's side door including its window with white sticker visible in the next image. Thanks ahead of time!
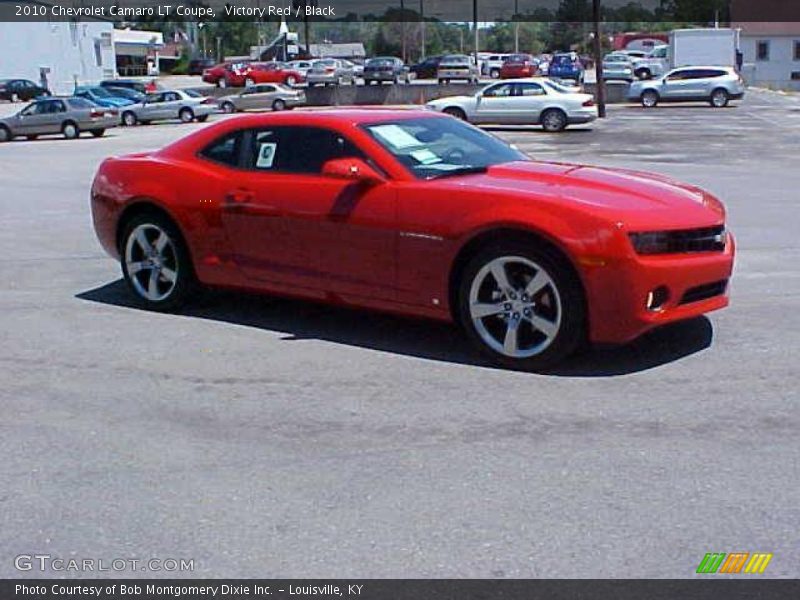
[220,127,396,299]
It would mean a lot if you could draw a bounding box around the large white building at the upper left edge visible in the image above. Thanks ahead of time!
[0,21,116,94]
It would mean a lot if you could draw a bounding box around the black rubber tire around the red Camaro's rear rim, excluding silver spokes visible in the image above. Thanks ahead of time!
[119,212,197,311]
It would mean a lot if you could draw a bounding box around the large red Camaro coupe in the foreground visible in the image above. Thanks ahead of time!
[91,109,734,370]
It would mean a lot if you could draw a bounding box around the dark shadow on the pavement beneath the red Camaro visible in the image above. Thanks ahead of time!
[76,279,713,377]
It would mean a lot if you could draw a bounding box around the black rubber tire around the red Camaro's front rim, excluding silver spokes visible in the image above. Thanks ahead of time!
[457,240,586,371]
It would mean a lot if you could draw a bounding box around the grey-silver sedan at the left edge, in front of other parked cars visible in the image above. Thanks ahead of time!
[0,96,119,142]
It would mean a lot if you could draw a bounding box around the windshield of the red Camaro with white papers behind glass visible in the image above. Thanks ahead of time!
[363,117,528,179]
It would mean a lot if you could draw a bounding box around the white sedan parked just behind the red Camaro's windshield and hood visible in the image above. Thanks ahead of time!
[427,78,597,131]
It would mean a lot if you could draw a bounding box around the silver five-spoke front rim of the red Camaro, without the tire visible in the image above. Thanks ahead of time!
[469,256,562,358]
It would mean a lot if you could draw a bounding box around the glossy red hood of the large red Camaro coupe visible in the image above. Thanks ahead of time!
[452,161,725,228]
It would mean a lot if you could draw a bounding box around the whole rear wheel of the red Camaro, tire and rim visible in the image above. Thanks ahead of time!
[120,214,195,311]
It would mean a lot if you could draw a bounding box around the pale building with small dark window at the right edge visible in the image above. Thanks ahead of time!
[732,21,800,91]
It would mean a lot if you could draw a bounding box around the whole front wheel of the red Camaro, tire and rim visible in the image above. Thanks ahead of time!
[458,242,585,371]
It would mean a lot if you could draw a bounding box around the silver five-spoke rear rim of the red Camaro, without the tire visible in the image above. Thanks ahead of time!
[125,223,179,302]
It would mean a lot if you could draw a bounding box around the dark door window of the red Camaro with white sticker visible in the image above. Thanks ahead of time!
[250,127,364,174]
